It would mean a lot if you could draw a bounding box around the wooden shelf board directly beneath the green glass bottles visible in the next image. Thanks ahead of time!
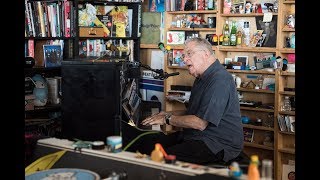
[218,45,276,53]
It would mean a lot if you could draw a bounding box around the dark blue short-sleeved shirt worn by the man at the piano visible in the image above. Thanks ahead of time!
[183,60,243,161]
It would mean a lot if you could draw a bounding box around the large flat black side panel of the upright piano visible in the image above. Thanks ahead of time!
[61,61,121,142]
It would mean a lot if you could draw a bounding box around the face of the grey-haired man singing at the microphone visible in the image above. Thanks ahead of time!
[183,42,206,77]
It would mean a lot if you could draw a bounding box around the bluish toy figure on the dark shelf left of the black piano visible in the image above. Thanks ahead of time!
[32,74,48,106]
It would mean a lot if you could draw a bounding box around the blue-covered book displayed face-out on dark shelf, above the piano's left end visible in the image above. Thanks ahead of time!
[43,45,63,67]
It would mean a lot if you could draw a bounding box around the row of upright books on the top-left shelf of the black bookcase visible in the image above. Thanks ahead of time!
[25,0,75,37]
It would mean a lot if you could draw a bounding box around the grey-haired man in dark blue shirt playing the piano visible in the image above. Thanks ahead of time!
[142,38,243,164]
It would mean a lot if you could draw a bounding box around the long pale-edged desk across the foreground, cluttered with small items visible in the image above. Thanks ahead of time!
[28,138,246,179]
